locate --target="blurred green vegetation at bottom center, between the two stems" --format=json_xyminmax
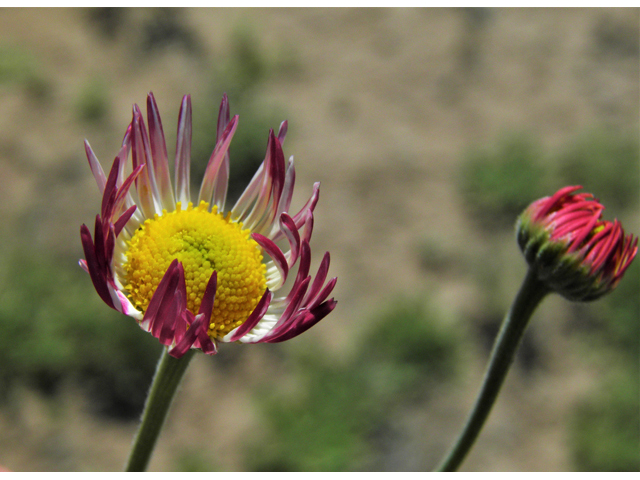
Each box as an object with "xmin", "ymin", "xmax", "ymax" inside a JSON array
[{"xmin": 246, "ymin": 299, "xmax": 460, "ymax": 471}]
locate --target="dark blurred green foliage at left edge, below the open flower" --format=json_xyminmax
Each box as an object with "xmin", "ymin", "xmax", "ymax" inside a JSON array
[{"xmin": 0, "ymin": 249, "xmax": 160, "ymax": 418}]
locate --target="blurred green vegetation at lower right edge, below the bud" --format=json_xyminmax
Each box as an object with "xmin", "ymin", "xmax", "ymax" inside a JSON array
[{"xmin": 571, "ymin": 261, "xmax": 640, "ymax": 471}]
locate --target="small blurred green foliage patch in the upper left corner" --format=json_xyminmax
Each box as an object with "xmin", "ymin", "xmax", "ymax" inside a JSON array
[{"xmin": 0, "ymin": 45, "xmax": 51, "ymax": 100}]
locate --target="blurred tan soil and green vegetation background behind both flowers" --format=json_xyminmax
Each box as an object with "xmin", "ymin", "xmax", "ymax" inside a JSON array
[{"xmin": 0, "ymin": 8, "xmax": 640, "ymax": 471}]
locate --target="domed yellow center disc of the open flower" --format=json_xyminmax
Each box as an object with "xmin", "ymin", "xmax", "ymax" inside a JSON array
[{"xmin": 124, "ymin": 202, "xmax": 266, "ymax": 338}]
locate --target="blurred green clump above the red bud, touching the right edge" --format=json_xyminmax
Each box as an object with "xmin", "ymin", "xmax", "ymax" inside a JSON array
[{"xmin": 554, "ymin": 128, "xmax": 640, "ymax": 211}]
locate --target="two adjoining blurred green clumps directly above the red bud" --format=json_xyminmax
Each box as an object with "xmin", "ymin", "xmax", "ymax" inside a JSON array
[{"xmin": 458, "ymin": 127, "xmax": 640, "ymax": 231}]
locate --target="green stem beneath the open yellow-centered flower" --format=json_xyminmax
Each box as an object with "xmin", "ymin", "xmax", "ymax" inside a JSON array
[{"xmin": 126, "ymin": 349, "xmax": 195, "ymax": 472}]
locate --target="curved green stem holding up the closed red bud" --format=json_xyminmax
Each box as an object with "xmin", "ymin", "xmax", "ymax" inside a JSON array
[{"xmin": 438, "ymin": 268, "xmax": 550, "ymax": 472}]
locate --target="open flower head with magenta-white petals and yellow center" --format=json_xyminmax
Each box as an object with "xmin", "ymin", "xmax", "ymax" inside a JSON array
[{"xmin": 80, "ymin": 93, "xmax": 337, "ymax": 357}]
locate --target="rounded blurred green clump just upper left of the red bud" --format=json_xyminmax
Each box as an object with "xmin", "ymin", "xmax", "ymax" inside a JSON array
[{"xmin": 459, "ymin": 133, "xmax": 544, "ymax": 230}]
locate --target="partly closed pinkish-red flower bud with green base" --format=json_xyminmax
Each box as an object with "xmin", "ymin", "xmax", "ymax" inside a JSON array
[{"xmin": 516, "ymin": 186, "xmax": 638, "ymax": 301}]
